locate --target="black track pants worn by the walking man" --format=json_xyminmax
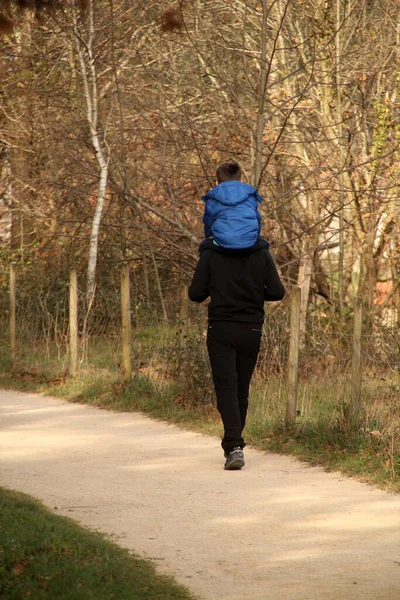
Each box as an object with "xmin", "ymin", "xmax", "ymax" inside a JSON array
[{"xmin": 207, "ymin": 321, "xmax": 262, "ymax": 453}]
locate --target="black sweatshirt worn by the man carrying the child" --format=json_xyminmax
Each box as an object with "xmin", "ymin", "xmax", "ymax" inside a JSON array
[{"xmin": 189, "ymin": 239, "xmax": 285, "ymax": 324}]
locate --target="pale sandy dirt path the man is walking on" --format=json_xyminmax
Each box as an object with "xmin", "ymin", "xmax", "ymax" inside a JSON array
[{"xmin": 0, "ymin": 391, "xmax": 400, "ymax": 600}]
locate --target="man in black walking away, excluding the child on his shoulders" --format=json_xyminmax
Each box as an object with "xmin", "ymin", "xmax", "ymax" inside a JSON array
[{"xmin": 189, "ymin": 238, "xmax": 285, "ymax": 470}]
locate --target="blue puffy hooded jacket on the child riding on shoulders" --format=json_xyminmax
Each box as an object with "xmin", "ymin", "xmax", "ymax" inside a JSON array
[{"xmin": 201, "ymin": 180, "xmax": 262, "ymax": 249}]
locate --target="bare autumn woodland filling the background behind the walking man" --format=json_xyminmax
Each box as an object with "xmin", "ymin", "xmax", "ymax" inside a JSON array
[{"xmin": 0, "ymin": 0, "xmax": 400, "ymax": 482}]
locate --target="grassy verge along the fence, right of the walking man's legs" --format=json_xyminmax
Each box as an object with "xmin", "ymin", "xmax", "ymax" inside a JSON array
[{"xmin": 246, "ymin": 377, "xmax": 400, "ymax": 492}]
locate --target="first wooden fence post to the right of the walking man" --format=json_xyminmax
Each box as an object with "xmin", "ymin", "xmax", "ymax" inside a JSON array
[{"xmin": 286, "ymin": 287, "xmax": 301, "ymax": 427}]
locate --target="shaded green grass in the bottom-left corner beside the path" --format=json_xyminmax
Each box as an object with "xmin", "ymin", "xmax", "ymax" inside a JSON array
[{"xmin": 0, "ymin": 488, "xmax": 194, "ymax": 600}]
